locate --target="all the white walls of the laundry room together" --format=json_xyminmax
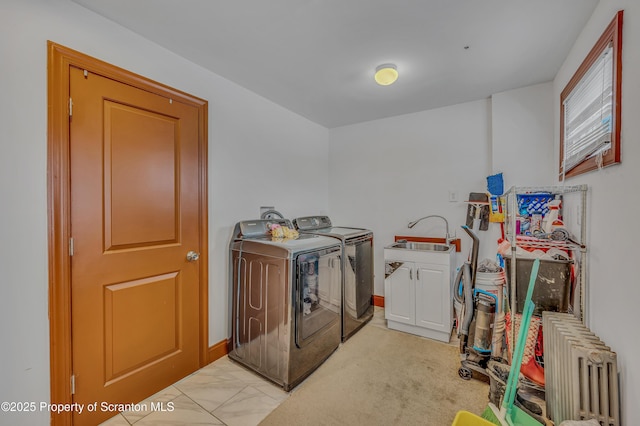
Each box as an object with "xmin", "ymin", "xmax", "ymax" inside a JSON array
[{"xmin": 0, "ymin": 0, "xmax": 640, "ymax": 424}]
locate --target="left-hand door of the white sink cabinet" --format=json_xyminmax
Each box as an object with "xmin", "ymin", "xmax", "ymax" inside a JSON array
[{"xmin": 384, "ymin": 262, "xmax": 416, "ymax": 325}]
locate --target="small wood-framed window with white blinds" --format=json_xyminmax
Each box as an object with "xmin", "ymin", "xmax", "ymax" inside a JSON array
[{"xmin": 560, "ymin": 11, "xmax": 623, "ymax": 180}]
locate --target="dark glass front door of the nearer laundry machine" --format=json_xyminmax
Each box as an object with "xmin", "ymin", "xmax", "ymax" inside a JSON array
[{"xmin": 295, "ymin": 245, "xmax": 342, "ymax": 348}]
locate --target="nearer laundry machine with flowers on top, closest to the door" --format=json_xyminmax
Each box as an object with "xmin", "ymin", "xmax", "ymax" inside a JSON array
[{"xmin": 229, "ymin": 219, "xmax": 342, "ymax": 391}]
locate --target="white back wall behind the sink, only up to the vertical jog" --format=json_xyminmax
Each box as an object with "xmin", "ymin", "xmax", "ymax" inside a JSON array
[{"xmin": 329, "ymin": 100, "xmax": 495, "ymax": 296}]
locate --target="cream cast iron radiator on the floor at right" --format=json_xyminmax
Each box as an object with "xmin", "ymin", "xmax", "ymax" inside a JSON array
[{"xmin": 542, "ymin": 312, "xmax": 620, "ymax": 426}]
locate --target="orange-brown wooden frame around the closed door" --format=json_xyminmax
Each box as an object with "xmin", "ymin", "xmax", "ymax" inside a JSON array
[{"xmin": 47, "ymin": 41, "xmax": 209, "ymax": 425}]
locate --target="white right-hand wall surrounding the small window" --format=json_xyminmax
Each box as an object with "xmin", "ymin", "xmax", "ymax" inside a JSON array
[{"xmin": 553, "ymin": 0, "xmax": 640, "ymax": 425}]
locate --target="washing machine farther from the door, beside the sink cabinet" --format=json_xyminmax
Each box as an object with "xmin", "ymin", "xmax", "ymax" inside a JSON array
[{"xmin": 293, "ymin": 216, "xmax": 374, "ymax": 341}]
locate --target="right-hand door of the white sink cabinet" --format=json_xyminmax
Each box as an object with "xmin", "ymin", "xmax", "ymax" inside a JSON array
[{"xmin": 415, "ymin": 263, "xmax": 452, "ymax": 333}]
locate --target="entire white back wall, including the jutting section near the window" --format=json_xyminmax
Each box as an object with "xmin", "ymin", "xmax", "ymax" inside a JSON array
[{"xmin": 329, "ymin": 83, "xmax": 555, "ymax": 296}]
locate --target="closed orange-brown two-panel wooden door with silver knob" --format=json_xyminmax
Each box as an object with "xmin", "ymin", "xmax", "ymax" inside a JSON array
[{"xmin": 69, "ymin": 67, "xmax": 200, "ymax": 424}]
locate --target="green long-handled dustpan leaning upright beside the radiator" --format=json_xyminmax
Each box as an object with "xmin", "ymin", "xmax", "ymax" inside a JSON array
[{"xmin": 483, "ymin": 259, "xmax": 541, "ymax": 426}]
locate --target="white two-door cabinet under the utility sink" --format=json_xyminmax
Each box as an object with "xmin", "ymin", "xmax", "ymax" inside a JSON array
[{"xmin": 384, "ymin": 247, "xmax": 454, "ymax": 342}]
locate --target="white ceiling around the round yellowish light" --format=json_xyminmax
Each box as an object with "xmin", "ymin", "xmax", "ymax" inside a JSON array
[{"xmin": 73, "ymin": 0, "xmax": 598, "ymax": 128}]
